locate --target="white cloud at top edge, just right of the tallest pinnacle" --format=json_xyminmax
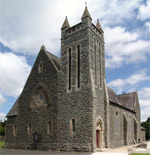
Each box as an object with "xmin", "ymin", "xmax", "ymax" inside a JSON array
[{"xmin": 88, "ymin": 0, "xmax": 142, "ymax": 25}]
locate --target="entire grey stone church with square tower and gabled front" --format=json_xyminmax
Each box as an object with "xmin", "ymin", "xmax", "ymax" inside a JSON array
[{"xmin": 6, "ymin": 7, "xmax": 140, "ymax": 152}]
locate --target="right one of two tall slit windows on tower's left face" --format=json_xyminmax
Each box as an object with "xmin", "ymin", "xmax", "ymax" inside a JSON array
[{"xmin": 77, "ymin": 45, "xmax": 81, "ymax": 88}]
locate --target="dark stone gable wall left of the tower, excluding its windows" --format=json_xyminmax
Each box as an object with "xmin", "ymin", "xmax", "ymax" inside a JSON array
[{"xmin": 6, "ymin": 50, "xmax": 58, "ymax": 149}]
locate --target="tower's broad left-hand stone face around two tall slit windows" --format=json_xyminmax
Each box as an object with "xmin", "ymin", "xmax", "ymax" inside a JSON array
[{"xmin": 58, "ymin": 17, "xmax": 93, "ymax": 151}]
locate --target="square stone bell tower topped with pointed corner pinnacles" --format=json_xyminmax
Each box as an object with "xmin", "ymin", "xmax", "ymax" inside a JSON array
[{"xmin": 58, "ymin": 7, "xmax": 105, "ymax": 151}]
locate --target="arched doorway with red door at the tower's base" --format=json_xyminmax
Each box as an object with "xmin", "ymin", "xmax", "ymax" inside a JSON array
[{"xmin": 96, "ymin": 120, "xmax": 103, "ymax": 148}]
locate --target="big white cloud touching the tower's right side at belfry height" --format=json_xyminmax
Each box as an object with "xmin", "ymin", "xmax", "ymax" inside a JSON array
[{"xmin": 104, "ymin": 27, "xmax": 150, "ymax": 69}]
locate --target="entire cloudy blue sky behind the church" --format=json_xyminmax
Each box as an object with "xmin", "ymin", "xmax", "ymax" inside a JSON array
[{"xmin": 0, "ymin": 0, "xmax": 150, "ymax": 120}]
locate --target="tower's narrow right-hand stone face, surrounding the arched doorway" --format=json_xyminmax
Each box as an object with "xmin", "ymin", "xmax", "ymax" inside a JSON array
[{"xmin": 89, "ymin": 24, "xmax": 105, "ymax": 151}]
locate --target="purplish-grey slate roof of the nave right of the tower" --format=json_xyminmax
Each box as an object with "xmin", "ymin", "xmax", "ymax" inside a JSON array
[{"xmin": 107, "ymin": 88, "xmax": 136, "ymax": 111}]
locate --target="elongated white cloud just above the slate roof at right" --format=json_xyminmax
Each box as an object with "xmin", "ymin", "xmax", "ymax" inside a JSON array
[{"xmin": 107, "ymin": 69, "xmax": 150, "ymax": 93}]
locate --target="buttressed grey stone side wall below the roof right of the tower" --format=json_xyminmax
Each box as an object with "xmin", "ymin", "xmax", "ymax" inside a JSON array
[{"xmin": 110, "ymin": 103, "xmax": 140, "ymax": 148}]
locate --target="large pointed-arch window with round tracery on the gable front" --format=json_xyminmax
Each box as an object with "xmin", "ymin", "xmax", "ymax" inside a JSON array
[{"xmin": 31, "ymin": 85, "xmax": 48, "ymax": 107}]
